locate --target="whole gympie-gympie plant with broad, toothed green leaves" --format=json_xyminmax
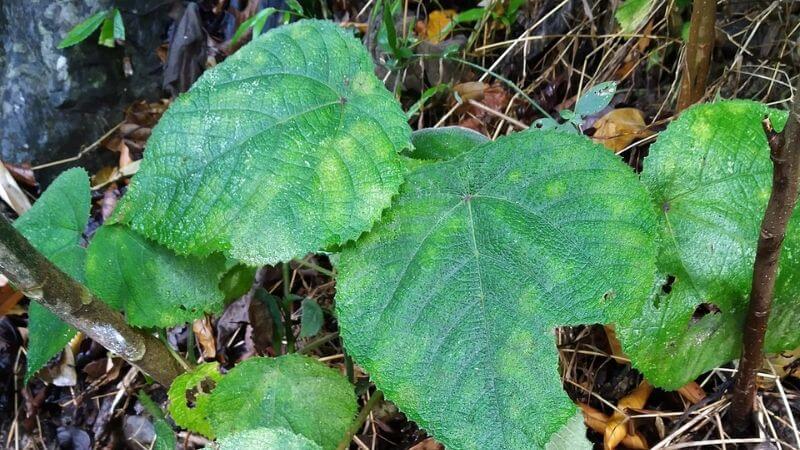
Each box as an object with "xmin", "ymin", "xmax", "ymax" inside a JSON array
[{"xmin": 15, "ymin": 21, "xmax": 800, "ymax": 449}]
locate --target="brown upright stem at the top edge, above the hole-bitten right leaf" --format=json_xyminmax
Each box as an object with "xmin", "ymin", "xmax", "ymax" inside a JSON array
[{"xmin": 676, "ymin": 0, "xmax": 717, "ymax": 112}]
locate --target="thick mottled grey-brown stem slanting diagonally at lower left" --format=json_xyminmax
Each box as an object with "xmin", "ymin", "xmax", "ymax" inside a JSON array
[{"xmin": 0, "ymin": 215, "xmax": 184, "ymax": 386}]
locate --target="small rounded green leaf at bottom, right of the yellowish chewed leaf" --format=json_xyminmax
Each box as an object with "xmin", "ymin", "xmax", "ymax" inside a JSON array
[{"xmin": 208, "ymin": 355, "xmax": 356, "ymax": 449}]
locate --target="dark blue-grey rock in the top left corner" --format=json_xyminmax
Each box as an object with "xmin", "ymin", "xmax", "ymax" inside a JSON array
[{"xmin": 0, "ymin": 0, "xmax": 174, "ymax": 178}]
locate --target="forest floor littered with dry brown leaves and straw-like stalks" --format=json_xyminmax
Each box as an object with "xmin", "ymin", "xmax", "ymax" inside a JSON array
[{"xmin": 0, "ymin": 0, "xmax": 800, "ymax": 450}]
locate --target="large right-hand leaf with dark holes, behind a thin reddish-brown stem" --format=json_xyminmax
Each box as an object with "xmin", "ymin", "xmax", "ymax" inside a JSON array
[{"xmin": 618, "ymin": 101, "xmax": 800, "ymax": 389}]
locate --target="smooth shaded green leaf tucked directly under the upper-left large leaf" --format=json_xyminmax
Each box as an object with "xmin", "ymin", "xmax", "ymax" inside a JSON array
[{"xmin": 86, "ymin": 224, "xmax": 225, "ymax": 327}]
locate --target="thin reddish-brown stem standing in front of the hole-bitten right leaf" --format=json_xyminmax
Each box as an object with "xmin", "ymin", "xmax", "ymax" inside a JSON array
[{"xmin": 731, "ymin": 99, "xmax": 800, "ymax": 431}]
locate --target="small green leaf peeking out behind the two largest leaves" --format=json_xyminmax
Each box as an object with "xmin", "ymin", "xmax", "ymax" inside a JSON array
[{"xmin": 409, "ymin": 127, "xmax": 489, "ymax": 161}]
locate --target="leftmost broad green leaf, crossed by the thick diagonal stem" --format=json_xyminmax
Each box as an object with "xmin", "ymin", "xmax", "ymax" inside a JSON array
[{"xmin": 14, "ymin": 169, "xmax": 91, "ymax": 380}]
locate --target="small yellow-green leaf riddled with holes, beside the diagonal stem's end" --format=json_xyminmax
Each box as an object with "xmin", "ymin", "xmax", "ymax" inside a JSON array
[{"xmin": 167, "ymin": 362, "xmax": 222, "ymax": 438}]
